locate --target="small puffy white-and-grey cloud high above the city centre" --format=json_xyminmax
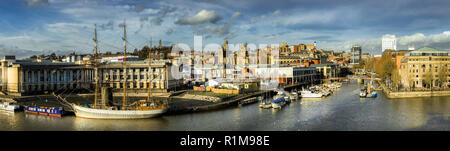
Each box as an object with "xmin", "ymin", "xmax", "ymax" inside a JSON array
[{"xmin": 175, "ymin": 10, "xmax": 222, "ymax": 25}]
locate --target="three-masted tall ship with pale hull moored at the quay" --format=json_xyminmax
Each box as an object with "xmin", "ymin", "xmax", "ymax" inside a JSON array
[{"xmin": 70, "ymin": 20, "xmax": 168, "ymax": 119}]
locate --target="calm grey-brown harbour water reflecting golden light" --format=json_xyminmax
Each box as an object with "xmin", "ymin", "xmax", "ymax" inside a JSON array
[{"xmin": 0, "ymin": 83, "xmax": 450, "ymax": 131}]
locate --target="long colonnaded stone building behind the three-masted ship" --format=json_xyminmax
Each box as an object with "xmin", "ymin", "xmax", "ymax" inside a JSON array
[{"xmin": 0, "ymin": 56, "xmax": 182, "ymax": 95}]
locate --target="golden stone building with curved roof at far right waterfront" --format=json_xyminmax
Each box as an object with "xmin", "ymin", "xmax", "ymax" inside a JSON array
[{"xmin": 399, "ymin": 47, "xmax": 450, "ymax": 88}]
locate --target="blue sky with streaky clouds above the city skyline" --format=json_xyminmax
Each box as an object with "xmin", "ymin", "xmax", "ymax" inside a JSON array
[{"xmin": 0, "ymin": 0, "xmax": 450, "ymax": 58}]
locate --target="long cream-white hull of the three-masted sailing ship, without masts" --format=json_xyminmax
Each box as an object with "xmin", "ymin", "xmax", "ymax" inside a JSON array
[{"xmin": 73, "ymin": 105, "xmax": 167, "ymax": 119}]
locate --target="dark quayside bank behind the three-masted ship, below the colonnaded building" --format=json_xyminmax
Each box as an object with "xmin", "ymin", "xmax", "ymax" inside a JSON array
[{"xmin": 0, "ymin": 91, "xmax": 270, "ymax": 114}]
